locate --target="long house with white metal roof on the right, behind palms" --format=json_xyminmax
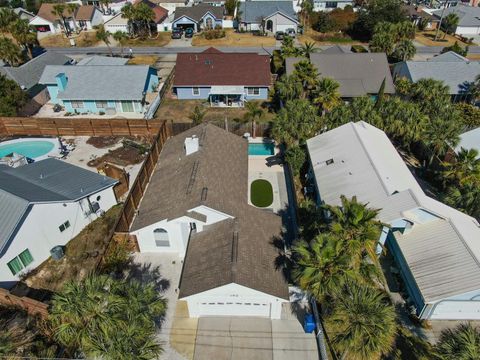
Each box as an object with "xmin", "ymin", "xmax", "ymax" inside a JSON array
[{"xmin": 307, "ymin": 121, "xmax": 480, "ymax": 320}]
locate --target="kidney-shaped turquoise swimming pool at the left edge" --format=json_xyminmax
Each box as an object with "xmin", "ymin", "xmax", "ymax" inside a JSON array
[{"xmin": 0, "ymin": 138, "xmax": 58, "ymax": 160}]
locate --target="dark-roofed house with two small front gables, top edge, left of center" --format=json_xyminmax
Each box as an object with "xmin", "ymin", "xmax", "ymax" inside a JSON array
[{"xmin": 172, "ymin": 4, "xmax": 225, "ymax": 32}]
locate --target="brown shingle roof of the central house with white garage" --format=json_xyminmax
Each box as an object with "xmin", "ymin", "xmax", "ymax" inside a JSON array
[{"xmin": 131, "ymin": 124, "xmax": 288, "ymax": 299}]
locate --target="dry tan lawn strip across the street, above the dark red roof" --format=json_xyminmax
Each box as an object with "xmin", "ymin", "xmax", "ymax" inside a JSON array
[{"xmin": 192, "ymin": 29, "xmax": 275, "ymax": 46}]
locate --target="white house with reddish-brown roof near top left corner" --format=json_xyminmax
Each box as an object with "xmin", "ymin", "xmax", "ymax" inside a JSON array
[{"xmin": 30, "ymin": 3, "xmax": 103, "ymax": 34}]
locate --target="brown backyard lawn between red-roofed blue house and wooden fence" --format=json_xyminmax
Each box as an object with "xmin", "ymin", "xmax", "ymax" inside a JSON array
[{"xmin": 156, "ymin": 99, "xmax": 274, "ymax": 123}]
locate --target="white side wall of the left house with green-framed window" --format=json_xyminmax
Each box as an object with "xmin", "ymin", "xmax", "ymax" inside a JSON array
[{"xmin": 0, "ymin": 187, "xmax": 117, "ymax": 287}]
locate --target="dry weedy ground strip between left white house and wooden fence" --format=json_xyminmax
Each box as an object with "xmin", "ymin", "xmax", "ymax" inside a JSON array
[{"xmin": 25, "ymin": 205, "xmax": 121, "ymax": 292}]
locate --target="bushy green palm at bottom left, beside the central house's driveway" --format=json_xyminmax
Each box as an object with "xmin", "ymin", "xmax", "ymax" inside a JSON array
[{"xmin": 49, "ymin": 274, "xmax": 166, "ymax": 359}]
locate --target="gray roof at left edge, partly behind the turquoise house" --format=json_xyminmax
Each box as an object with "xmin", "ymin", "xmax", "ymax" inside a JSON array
[{"xmin": 0, "ymin": 51, "xmax": 72, "ymax": 94}]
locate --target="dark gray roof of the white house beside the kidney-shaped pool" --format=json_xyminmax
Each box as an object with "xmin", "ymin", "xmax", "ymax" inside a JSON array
[{"xmin": 0, "ymin": 159, "xmax": 117, "ymax": 253}]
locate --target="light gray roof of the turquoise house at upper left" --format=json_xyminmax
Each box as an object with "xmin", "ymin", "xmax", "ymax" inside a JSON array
[{"xmin": 40, "ymin": 65, "xmax": 156, "ymax": 100}]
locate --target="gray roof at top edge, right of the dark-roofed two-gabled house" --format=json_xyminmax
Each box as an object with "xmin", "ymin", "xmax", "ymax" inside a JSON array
[{"xmin": 239, "ymin": 1, "xmax": 298, "ymax": 23}]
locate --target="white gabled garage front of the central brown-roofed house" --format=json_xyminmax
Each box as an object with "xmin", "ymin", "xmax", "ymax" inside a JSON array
[{"xmin": 182, "ymin": 283, "xmax": 287, "ymax": 319}]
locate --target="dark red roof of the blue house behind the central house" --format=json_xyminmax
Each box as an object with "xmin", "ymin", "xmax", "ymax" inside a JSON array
[{"xmin": 173, "ymin": 48, "xmax": 271, "ymax": 86}]
